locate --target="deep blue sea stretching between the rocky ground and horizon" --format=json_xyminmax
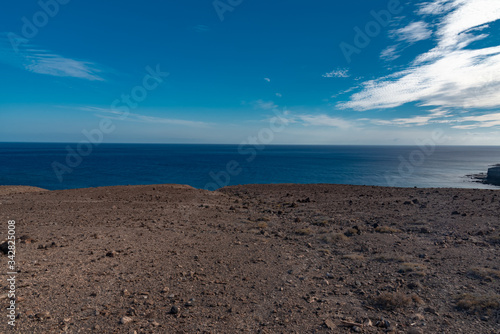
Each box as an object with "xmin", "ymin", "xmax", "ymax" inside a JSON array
[{"xmin": 0, "ymin": 143, "xmax": 500, "ymax": 190}]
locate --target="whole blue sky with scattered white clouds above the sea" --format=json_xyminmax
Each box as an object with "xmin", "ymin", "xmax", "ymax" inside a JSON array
[{"xmin": 0, "ymin": 0, "xmax": 500, "ymax": 145}]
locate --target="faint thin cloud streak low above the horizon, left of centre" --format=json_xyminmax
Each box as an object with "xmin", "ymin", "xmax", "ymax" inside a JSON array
[{"xmin": 79, "ymin": 107, "xmax": 210, "ymax": 128}]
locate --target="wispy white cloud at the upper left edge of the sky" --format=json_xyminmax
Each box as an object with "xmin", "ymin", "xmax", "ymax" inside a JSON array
[{"xmin": 0, "ymin": 35, "xmax": 104, "ymax": 81}]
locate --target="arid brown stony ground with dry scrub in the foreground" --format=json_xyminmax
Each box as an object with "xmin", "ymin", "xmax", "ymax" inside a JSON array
[{"xmin": 0, "ymin": 185, "xmax": 500, "ymax": 334}]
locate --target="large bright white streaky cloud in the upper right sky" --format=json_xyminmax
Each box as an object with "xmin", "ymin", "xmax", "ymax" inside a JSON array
[{"xmin": 338, "ymin": 0, "xmax": 500, "ymax": 121}]
